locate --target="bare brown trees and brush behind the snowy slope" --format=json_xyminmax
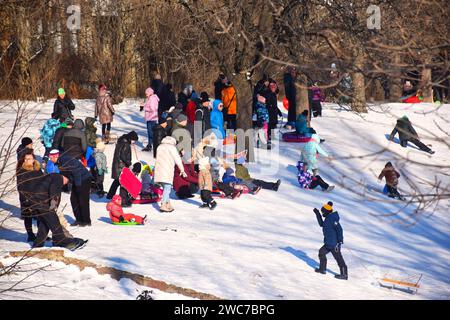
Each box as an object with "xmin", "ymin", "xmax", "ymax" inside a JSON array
[{"xmin": 0, "ymin": 0, "xmax": 450, "ymax": 129}]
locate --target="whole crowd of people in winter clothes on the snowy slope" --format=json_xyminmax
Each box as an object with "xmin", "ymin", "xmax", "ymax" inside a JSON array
[{"xmin": 17, "ymin": 68, "xmax": 434, "ymax": 279}]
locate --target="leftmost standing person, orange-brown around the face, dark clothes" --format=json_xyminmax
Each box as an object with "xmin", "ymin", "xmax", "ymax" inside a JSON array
[{"xmin": 16, "ymin": 149, "xmax": 44, "ymax": 242}]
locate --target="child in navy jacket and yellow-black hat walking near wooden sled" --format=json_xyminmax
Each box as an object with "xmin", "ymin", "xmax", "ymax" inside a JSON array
[{"xmin": 313, "ymin": 201, "xmax": 348, "ymax": 280}]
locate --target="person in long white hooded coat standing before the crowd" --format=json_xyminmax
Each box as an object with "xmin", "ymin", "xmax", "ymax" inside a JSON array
[{"xmin": 155, "ymin": 136, "xmax": 187, "ymax": 212}]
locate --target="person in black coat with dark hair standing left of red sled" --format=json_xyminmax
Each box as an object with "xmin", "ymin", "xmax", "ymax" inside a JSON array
[{"xmin": 106, "ymin": 131, "xmax": 138, "ymax": 207}]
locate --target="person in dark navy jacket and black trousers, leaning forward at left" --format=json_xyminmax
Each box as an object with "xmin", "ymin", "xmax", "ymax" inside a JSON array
[{"xmin": 56, "ymin": 154, "xmax": 92, "ymax": 227}]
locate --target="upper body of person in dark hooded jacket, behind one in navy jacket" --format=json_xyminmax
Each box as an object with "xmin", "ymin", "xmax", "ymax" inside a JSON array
[{"xmin": 61, "ymin": 119, "xmax": 87, "ymax": 160}]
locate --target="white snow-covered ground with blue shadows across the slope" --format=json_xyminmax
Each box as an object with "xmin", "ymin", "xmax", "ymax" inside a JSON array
[{"xmin": 0, "ymin": 100, "xmax": 450, "ymax": 299}]
